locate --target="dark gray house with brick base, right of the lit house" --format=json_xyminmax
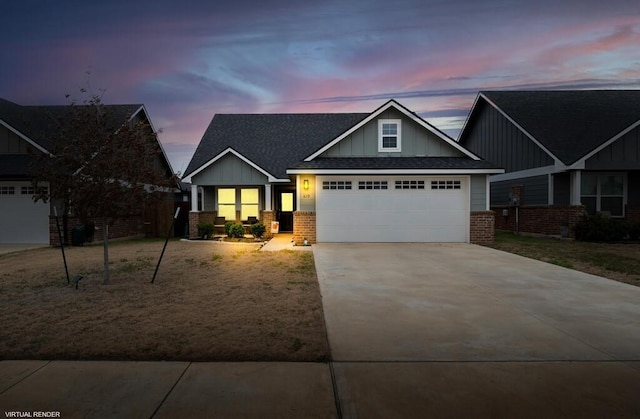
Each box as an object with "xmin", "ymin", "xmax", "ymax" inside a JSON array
[{"xmin": 459, "ymin": 90, "xmax": 640, "ymax": 235}]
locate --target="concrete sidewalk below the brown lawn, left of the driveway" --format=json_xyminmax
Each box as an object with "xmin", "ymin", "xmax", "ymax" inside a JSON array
[{"xmin": 0, "ymin": 361, "xmax": 337, "ymax": 418}]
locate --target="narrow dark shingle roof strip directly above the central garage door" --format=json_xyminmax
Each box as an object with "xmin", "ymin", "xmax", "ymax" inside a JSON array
[{"xmin": 291, "ymin": 157, "xmax": 499, "ymax": 170}]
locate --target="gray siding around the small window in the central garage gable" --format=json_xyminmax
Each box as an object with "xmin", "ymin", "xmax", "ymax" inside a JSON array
[{"xmin": 321, "ymin": 109, "xmax": 463, "ymax": 157}]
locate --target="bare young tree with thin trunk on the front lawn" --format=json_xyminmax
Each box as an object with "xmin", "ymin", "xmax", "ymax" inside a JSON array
[{"xmin": 32, "ymin": 89, "xmax": 176, "ymax": 284}]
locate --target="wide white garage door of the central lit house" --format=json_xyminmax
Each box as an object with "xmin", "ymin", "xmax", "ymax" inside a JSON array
[{"xmin": 316, "ymin": 176, "xmax": 469, "ymax": 242}]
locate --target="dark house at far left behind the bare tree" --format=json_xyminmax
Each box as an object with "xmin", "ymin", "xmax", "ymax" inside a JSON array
[{"xmin": 0, "ymin": 99, "xmax": 179, "ymax": 244}]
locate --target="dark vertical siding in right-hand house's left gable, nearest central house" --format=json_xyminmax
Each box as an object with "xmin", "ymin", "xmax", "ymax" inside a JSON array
[{"xmin": 460, "ymin": 104, "xmax": 554, "ymax": 173}]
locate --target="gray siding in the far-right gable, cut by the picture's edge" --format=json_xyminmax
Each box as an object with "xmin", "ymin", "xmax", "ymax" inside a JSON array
[{"xmin": 585, "ymin": 124, "xmax": 640, "ymax": 170}]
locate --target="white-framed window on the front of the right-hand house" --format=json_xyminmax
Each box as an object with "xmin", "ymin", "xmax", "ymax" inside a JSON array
[{"xmin": 580, "ymin": 173, "xmax": 625, "ymax": 217}]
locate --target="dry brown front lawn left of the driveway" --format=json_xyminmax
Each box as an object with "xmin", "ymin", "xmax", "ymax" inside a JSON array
[{"xmin": 0, "ymin": 240, "xmax": 330, "ymax": 361}]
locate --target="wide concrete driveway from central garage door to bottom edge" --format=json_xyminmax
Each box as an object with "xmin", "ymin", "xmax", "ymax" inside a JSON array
[{"xmin": 314, "ymin": 244, "xmax": 640, "ymax": 417}]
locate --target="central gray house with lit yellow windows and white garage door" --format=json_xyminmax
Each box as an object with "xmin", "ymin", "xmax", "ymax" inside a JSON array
[{"xmin": 185, "ymin": 100, "xmax": 503, "ymax": 244}]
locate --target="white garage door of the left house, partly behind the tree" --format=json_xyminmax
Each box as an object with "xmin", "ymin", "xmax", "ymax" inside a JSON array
[{"xmin": 0, "ymin": 182, "xmax": 49, "ymax": 244}]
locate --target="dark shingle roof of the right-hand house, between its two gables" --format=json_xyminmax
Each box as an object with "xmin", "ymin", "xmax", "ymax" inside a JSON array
[{"xmin": 480, "ymin": 90, "xmax": 640, "ymax": 164}]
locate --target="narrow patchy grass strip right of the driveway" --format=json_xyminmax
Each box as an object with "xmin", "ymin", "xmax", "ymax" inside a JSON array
[{"xmin": 489, "ymin": 231, "xmax": 640, "ymax": 286}]
